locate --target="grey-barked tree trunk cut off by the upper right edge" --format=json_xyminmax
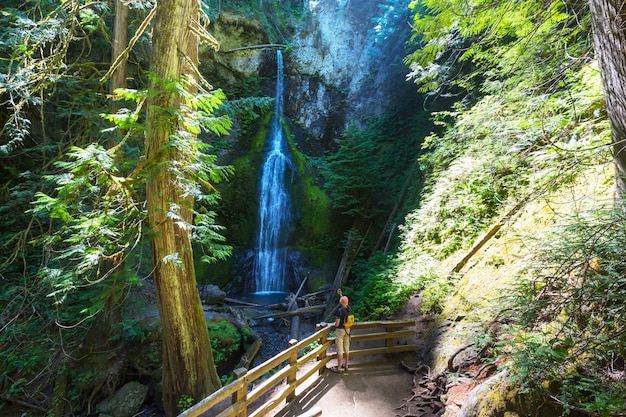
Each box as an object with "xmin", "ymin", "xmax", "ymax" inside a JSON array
[{"xmin": 589, "ymin": 0, "xmax": 626, "ymax": 200}]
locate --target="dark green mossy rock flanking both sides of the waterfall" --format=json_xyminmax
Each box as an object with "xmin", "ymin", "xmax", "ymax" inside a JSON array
[{"xmin": 197, "ymin": 112, "xmax": 343, "ymax": 290}]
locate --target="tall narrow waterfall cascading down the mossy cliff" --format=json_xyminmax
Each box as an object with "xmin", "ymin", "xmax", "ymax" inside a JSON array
[{"xmin": 254, "ymin": 50, "xmax": 293, "ymax": 293}]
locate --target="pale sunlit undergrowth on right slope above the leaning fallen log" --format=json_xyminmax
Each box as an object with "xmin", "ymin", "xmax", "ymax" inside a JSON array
[{"xmin": 398, "ymin": 59, "xmax": 610, "ymax": 259}]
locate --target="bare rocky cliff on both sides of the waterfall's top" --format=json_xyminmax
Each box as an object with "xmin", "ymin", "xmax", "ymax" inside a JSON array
[{"xmin": 206, "ymin": 0, "xmax": 418, "ymax": 146}]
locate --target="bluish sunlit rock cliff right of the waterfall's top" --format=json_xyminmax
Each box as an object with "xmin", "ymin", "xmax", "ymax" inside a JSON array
[{"xmin": 285, "ymin": 0, "xmax": 415, "ymax": 143}]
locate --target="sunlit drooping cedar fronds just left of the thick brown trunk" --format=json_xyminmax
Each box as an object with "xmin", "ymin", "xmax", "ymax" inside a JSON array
[{"xmin": 32, "ymin": 140, "xmax": 145, "ymax": 302}]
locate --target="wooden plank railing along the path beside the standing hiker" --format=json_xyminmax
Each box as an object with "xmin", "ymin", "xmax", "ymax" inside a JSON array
[{"xmin": 179, "ymin": 320, "xmax": 415, "ymax": 417}]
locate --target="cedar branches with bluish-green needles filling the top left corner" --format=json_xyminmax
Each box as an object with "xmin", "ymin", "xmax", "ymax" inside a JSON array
[{"xmin": 0, "ymin": 1, "xmax": 112, "ymax": 150}]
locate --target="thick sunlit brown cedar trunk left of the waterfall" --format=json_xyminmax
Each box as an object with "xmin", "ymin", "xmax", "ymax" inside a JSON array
[{"xmin": 146, "ymin": 0, "xmax": 221, "ymax": 416}]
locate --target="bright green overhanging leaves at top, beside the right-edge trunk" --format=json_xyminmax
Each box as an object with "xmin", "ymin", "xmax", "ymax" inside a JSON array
[{"xmin": 406, "ymin": 0, "xmax": 590, "ymax": 93}]
